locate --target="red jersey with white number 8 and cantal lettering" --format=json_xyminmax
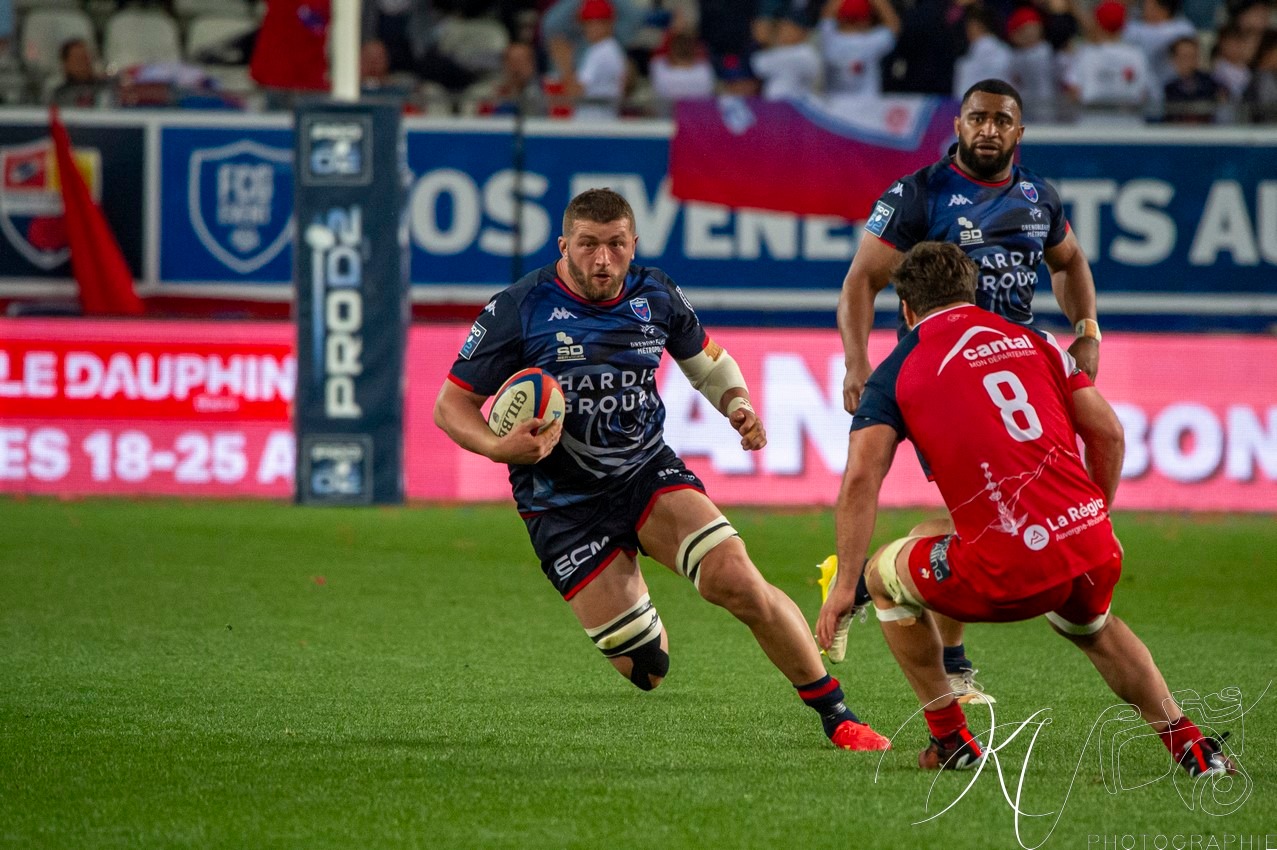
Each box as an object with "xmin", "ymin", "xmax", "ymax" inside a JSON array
[{"xmin": 852, "ymin": 305, "xmax": 1117, "ymax": 601}]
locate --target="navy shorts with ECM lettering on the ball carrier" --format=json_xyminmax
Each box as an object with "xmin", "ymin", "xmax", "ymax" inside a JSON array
[{"xmin": 524, "ymin": 445, "xmax": 705, "ymax": 599}]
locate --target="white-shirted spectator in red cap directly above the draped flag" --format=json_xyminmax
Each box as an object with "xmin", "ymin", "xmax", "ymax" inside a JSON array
[{"xmin": 819, "ymin": 0, "xmax": 900, "ymax": 94}]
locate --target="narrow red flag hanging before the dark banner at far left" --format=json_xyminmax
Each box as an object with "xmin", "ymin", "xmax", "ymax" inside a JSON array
[{"xmin": 49, "ymin": 106, "xmax": 146, "ymax": 315}]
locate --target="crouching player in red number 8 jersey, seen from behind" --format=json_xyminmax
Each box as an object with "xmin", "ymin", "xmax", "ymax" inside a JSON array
[{"xmin": 817, "ymin": 242, "xmax": 1234, "ymax": 776}]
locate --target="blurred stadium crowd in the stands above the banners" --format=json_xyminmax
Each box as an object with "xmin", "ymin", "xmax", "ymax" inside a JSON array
[{"xmin": 0, "ymin": 0, "xmax": 1277, "ymax": 124}]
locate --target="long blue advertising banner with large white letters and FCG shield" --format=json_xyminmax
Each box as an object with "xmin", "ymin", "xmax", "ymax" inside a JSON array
[{"xmin": 146, "ymin": 120, "xmax": 1277, "ymax": 324}]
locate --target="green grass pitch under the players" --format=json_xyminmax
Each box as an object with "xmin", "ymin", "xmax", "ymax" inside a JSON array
[{"xmin": 0, "ymin": 499, "xmax": 1277, "ymax": 850}]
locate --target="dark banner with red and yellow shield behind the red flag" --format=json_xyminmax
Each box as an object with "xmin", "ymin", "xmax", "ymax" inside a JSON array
[{"xmin": 0, "ymin": 121, "xmax": 146, "ymax": 280}]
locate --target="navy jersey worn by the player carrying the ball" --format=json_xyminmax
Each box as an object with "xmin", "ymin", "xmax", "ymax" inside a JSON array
[{"xmin": 448, "ymin": 264, "xmax": 709, "ymax": 513}]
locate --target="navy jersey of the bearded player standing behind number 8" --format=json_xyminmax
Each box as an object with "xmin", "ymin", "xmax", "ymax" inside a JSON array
[{"xmin": 865, "ymin": 145, "xmax": 1069, "ymax": 324}]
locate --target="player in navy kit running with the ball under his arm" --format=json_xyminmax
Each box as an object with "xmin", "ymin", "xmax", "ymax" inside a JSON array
[{"xmin": 434, "ymin": 189, "xmax": 889, "ymax": 749}]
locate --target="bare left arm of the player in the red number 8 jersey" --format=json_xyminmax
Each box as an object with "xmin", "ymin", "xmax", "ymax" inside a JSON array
[{"xmin": 816, "ymin": 425, "xmax": 899, "ymax": 650}]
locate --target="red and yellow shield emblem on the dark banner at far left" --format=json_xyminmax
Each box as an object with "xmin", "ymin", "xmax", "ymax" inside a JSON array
[{"xmin": 0, "ymin": 138, "xmax": 102, "ymax": 272}]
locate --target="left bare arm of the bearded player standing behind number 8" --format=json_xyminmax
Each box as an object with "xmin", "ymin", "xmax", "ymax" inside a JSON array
[{"xmin": 838, "ymin": 234, "xmax": 904, "ymax": 414}]
